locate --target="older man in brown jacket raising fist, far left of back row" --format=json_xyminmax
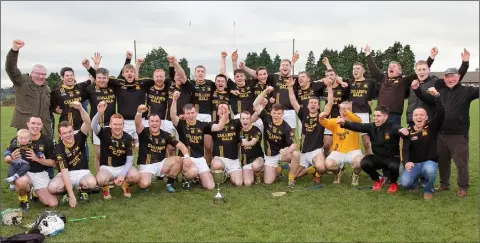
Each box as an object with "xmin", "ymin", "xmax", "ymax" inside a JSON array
[{"xmin": 5, "ymin": 40, "xmax": 53, "ymax": 139}]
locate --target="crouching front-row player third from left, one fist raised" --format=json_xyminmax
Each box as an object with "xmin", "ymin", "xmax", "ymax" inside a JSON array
[{"xmin": 92, "ymin": 102, "xmax": 139, "ymax": 199}]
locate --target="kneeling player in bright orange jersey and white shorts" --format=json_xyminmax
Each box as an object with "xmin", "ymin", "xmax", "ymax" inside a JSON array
[{"xmin": 320, "ymin": 101, "xmax": 363, "ymax": 186}]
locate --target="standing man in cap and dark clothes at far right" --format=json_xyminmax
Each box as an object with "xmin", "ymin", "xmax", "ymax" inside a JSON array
[{"xmin": 417, "ymin": 68, "xmax": 479, "ymax": 198}]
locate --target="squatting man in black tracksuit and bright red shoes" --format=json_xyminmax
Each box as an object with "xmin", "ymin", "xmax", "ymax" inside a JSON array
[{"xmin": 341, "ymin": 105, "xmax": 409, "ymax": 194}]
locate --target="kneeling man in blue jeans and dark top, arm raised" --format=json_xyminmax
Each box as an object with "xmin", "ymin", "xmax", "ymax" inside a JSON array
[{"xmin": 400, "ymin": 83, "xmax": 445, "ymax": 200}]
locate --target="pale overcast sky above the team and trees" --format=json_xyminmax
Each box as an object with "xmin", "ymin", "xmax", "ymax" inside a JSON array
[{"xmin": 1, "ymin": 1, "xmax": 479, "ymax": 87}]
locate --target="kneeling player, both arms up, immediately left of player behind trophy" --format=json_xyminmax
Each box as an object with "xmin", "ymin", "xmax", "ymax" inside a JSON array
[{"xmin": 170, "ymin": 91, "xmax": 227, "ymax": 190}]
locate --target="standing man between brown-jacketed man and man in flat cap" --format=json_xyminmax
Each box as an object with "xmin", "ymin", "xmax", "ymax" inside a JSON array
[{"xmin": 407, "ymin": 47, "xmax": 470, "ymax": 126}]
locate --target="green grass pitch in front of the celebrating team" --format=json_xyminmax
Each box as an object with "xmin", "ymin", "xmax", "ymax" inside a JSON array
[{"xmin": 0, "ymin": 101, "xmax": 479, "ymax": 242}]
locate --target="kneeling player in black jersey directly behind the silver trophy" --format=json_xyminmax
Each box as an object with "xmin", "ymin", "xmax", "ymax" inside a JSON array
[{"xmin": 211, "ymin": 103, "xmax": 243, "ymax": 186}]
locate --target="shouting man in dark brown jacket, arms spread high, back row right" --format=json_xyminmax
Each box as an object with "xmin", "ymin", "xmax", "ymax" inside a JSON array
[{"xmin": 363, "ymin": 45, "xmax": 434, "ymax": 125}]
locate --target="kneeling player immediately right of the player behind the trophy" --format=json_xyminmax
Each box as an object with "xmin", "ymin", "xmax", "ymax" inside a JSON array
[{"xmin": 240, "ymin": 111, "xmax": 265, "ymax": 186}]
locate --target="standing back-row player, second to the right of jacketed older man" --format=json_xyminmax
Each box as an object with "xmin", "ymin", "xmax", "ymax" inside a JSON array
[{"xmin": 85, "ymin": 68, "xmax": 117, "ymax": 172}]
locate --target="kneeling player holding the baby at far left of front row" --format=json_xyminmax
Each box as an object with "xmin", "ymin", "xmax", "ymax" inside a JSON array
[{"xmin": 4, "ymin": 116, "xmax": 58, "ymax": 211}]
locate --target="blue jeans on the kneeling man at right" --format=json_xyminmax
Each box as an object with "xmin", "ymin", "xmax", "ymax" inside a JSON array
[{"xmin": 400, "ymin": 160, "xmax": 438, "ymax": 193}]
